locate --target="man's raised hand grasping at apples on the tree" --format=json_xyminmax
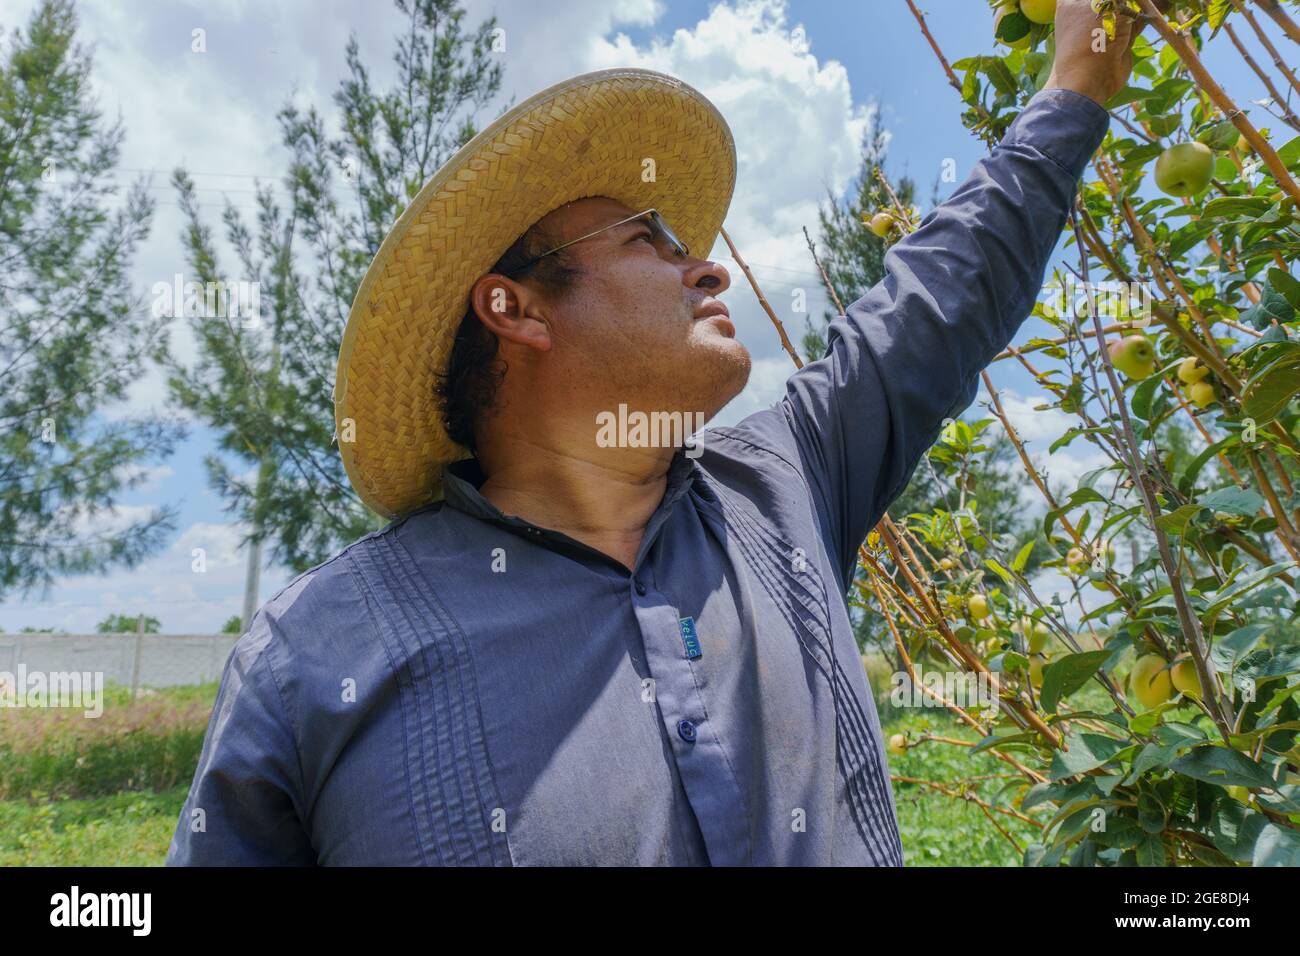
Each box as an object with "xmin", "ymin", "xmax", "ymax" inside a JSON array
[{"xmin": 1044, "ymin": 0, "xmax": 1167, "ymax": 104}]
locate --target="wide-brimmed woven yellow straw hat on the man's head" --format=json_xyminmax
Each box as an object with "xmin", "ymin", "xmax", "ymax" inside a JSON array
[{"xmin": 334, "ymin": 69, "xmax": 736, "ymax": 518}]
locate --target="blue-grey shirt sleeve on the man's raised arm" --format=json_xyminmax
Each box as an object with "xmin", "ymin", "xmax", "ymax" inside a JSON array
[{"xmin": 724, "ymin": 90, "xmax": 1109, "ymax": 589}]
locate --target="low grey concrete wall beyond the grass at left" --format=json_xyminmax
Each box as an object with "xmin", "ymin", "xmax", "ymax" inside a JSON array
[{"xmin": 0, "ymin": 633, "xmax": 239, "ymax": 687}]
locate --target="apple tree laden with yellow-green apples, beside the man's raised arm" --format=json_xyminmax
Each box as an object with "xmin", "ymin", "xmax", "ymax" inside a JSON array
[{"xmin": 832, "ymin": 0, "xmax": 1300, "ymax": 866}]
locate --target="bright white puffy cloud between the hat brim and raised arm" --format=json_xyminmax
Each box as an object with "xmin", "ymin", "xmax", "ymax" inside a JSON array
[{"xmin": 584, "ymin": 0, "xmax": 870, "ymax": 371}]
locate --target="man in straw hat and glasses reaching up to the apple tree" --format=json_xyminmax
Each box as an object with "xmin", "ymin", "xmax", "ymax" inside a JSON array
[{"xmin": 168, "ymin": 0, "xmax": 1130, "ymax": 865}]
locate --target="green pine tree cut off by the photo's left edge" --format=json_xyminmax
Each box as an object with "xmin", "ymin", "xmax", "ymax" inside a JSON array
[{"xmin": 0, "ymin": 0, "xmax": 183, "ymax": 594}]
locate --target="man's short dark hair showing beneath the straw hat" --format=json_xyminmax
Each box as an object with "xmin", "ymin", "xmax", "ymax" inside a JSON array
[{"xmin": 433, "ymin": 222, "xmax": 581, "ymax": 451}]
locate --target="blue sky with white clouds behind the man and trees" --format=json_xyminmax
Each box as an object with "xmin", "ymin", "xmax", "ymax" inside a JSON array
[{"xmin": 0, "ymin": 0, "xmax": 1288, "ymax": 633}]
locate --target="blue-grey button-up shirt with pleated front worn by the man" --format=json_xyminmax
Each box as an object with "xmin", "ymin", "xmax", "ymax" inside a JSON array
[{"xmin": 168, "ymin": 90, "xmax": 1108, "ymax": 866}]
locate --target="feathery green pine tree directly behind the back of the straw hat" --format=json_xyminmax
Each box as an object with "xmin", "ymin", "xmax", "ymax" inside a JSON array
[{"xmin": 169, "ymin": 0, "xmax": 502, "ymax": 571}]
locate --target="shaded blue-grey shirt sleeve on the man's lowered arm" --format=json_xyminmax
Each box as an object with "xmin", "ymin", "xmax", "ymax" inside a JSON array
[{"xmin": 166, "ymin": 609, "xmax": 316, "ymax": 866}]
